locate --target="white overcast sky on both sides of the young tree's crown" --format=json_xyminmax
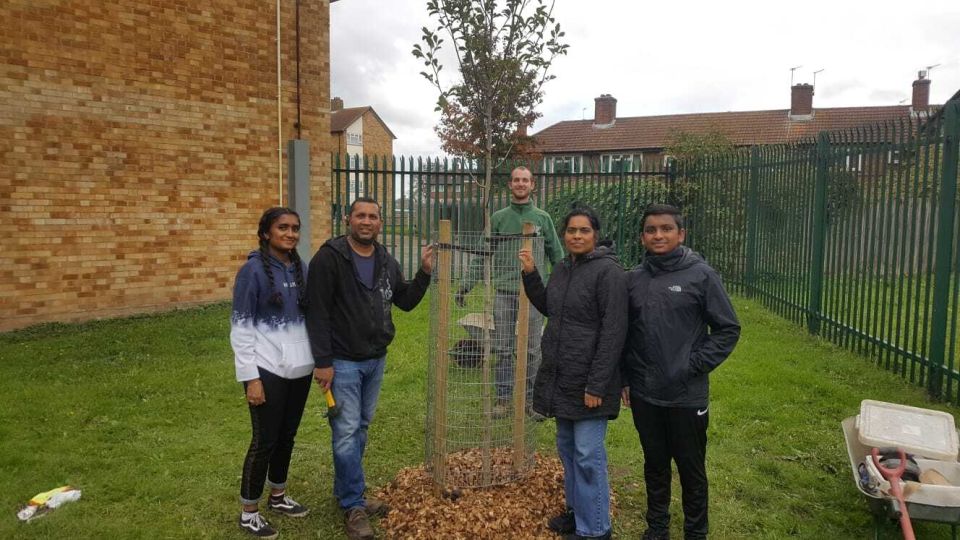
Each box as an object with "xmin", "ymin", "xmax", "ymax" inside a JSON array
[{"xmin": 330, "ymin": 0, "xmax": 960, "ymax": 156}]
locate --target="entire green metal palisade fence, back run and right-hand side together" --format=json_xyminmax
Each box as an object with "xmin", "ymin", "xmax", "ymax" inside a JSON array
[{"xmin": 331, "ymin": 102, "xmax": 960, "ymax": 403}]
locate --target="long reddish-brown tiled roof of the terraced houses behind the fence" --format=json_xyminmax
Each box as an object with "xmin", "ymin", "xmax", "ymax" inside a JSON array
[{"xmin": 533, "ymin": 105, "xmax": 933, "ymax": 153}]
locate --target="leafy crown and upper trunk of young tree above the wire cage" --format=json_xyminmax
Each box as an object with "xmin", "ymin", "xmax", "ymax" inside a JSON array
[{"xmin": 413, "ymin": 0, "xmax": 569, "ymax": 230}]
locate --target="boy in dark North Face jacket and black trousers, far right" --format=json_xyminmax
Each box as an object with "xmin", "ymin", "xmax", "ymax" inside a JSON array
[{"xmin": 623, "ymin": 205, "xmax": 740, "ymax": 540}]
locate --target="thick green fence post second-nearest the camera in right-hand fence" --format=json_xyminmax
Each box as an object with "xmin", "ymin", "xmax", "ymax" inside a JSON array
[{"xmin": 807, "ymin": 132, "xmax": 831, "ymax": 334}]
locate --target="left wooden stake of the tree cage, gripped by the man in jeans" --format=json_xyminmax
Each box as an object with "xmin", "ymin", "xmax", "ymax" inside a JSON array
[{"xmin": 433, "ymin": 219, "xmax": 453, "ymax": 488}]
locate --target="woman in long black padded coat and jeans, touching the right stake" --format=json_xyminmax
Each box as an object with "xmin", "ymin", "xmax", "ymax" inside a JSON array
[{"xmin": 520, "ymin": 209, "xmax": 627, "ymax": 539}]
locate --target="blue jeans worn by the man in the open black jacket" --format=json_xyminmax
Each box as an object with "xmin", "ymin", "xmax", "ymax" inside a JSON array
[{"xmin": 330, "ymin": 358, "xmax": 386, "ymax": 510}]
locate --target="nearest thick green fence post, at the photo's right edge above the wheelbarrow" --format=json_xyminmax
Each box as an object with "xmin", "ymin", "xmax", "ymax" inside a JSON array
[{"xmin": 927, "ymin": 102, "xmax": 960, "ymax": 398}]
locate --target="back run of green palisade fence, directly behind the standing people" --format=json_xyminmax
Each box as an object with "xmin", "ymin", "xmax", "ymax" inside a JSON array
[{"xmin": 330, "ymin": 155, "xmax": 680, "ymax": 275}]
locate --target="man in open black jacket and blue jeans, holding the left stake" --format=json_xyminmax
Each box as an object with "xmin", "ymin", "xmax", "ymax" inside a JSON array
[{"xmin": 306, "ymin": 197, "xmax": 433, "ymax": 539}]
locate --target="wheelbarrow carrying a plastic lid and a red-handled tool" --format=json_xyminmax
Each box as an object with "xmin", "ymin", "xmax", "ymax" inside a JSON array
[{"xmin": 841, "ymin": 416, "xmax": 960, "ymax": 540}]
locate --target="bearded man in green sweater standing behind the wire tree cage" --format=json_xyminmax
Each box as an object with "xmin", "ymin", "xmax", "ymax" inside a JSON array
[{"xmin": 456, "ymin": 166, "xmax": 563, "ymax": 418}]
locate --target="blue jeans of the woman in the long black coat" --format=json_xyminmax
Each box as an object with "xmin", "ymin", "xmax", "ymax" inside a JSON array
[{"xmin": 557, "ymin": 418, "xmax": 610, "ymax": 536}]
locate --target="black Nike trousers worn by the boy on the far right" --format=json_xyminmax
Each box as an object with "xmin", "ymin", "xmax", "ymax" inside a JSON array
[{"xmin": 630, "ymin": 394, "xmax": 710, "ymax": 540}]
